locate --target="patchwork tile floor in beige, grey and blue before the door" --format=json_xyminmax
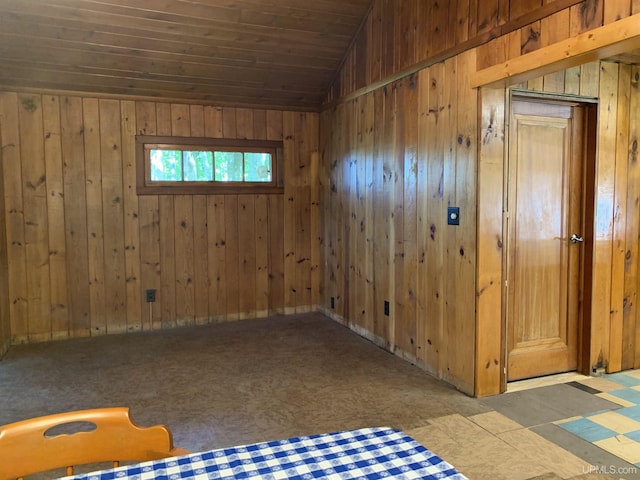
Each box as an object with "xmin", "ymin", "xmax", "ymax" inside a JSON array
[{"xmin": 468, "ymin": 371, "xmax": 640, "ymax": 480}]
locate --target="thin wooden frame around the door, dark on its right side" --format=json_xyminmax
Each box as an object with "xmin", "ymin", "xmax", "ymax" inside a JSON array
[{"xmin": 500, "ymin": 88, "xmax": 598, "ymax": 393}]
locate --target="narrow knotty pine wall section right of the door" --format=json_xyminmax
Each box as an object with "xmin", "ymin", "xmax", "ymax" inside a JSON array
[{"xmin": 591, "ymin": 62, "xmax": 640, "ymax": 372}]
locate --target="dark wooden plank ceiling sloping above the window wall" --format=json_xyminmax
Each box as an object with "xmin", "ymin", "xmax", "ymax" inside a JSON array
[{"xmin": 0, "ymin": 0, "xmax": 371, "ymax": 110}]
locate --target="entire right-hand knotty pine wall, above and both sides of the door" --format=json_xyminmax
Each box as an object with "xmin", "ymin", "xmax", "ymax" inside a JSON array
[{"xmin": 320, "ymin": 0, "xmax": 640, "ymax": 395}]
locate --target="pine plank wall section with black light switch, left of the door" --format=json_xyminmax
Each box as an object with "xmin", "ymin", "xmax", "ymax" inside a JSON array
[{"xmin": 320, "ymin": 52, "xmax": 477, "ymax": 393}]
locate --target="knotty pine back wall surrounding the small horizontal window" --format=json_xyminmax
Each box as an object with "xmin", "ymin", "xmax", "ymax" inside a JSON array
[{"xmin": 0, "ymin": 92, "xmax": 319, "ymax": 345}]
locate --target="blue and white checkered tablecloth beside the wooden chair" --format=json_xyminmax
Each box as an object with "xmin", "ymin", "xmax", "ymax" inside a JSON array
[{"xmin": 62, "ymin": 428, "xmax": 466, "ymax": 480}]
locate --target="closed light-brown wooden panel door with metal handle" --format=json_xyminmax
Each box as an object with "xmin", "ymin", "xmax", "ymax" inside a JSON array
[{"xmin": 506, "ymin": 100, "xmax": 584, "ymax": 380}]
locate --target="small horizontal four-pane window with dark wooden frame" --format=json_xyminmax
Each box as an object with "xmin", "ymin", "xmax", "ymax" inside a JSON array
[{"xmin": 136, "ymin": 135, "xmax": 283, "ymax": 195}]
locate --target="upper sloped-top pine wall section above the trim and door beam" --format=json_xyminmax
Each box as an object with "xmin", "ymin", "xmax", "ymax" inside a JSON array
[{"xmin": 327, "ymin": 0, "xmax": 640, "ymax": 102}]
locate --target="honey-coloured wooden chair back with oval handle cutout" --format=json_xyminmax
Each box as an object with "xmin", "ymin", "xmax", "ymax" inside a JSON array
[{"xmin": 0, "ymin": 407, "xmax": 189, "ymax": 480}]
